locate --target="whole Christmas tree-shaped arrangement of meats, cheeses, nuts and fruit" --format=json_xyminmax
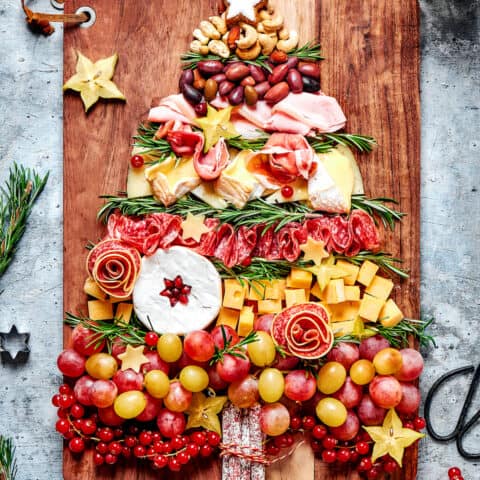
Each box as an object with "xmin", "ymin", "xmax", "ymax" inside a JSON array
[{"xmin": 52, "ymin": 0, "xmax": 430, "ymax": 480}]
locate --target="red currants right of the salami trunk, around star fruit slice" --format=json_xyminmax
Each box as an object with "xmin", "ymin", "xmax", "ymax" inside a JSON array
[{"xmin": 265, "ymin": 415, "xmax": 428, "ymax": 480}]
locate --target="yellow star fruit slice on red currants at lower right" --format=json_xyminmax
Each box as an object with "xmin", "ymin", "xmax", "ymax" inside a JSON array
[{"xmin": 363, "ymin": 408, "xmax": 425, "ymax": 467}]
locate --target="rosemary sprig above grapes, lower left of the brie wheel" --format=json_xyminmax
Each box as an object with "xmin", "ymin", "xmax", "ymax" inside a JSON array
[{"xmin": 64, "ymin": 312, "xmax": 147, "ymax": 352}]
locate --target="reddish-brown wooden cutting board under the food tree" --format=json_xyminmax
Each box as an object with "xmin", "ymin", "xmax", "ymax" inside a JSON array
[{"xmin": 64, "ymin": 0, "xmax": 420, "ymax": 480}]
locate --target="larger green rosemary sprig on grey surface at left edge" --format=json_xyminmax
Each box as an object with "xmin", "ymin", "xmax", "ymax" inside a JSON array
[{"xmin": 0, "ymin": 163, "xmax": 48, "ymax": 276}]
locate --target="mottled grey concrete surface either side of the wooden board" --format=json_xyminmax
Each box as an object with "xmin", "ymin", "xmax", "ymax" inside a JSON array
[{"xmin": 0, "ymin": 0, "xmax": 480, "ymax": 480}]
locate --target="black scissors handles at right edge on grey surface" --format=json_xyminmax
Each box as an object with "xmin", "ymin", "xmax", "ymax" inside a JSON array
[{"xmin": 425, "ymin": 365, "xmax": 480, "ymax": 460}]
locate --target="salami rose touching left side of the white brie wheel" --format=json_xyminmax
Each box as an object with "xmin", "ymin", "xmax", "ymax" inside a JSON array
[{"xmin": 87, "ymin": 240, "xmax": 141, "ymax": 298}]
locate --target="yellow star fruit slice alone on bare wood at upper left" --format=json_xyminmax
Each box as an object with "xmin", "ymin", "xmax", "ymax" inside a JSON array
[{"xmin": 63, "ymin": 52, "xmax": 125, "ymax": 112}]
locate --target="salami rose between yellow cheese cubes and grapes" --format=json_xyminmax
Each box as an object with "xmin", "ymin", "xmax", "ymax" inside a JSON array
[{"xmin": 271, "ymin": 303, "xmax": 333, "ymax": 359}]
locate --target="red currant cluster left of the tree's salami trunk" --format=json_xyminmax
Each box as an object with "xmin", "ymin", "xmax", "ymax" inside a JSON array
[{"xmin": 52, "ymin": 384, "xmax": 220, "ymax": 472}]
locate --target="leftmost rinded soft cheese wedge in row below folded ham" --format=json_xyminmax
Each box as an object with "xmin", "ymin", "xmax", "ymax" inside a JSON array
[{"xmin": 145, "ymin": 157, "xmax": 201, "ymax": 206}]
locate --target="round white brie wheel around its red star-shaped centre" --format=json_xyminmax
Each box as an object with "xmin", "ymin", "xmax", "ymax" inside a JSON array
[{"xmin": 133, "ymin": 247, "xmax": 222, "ymax": 335}]
